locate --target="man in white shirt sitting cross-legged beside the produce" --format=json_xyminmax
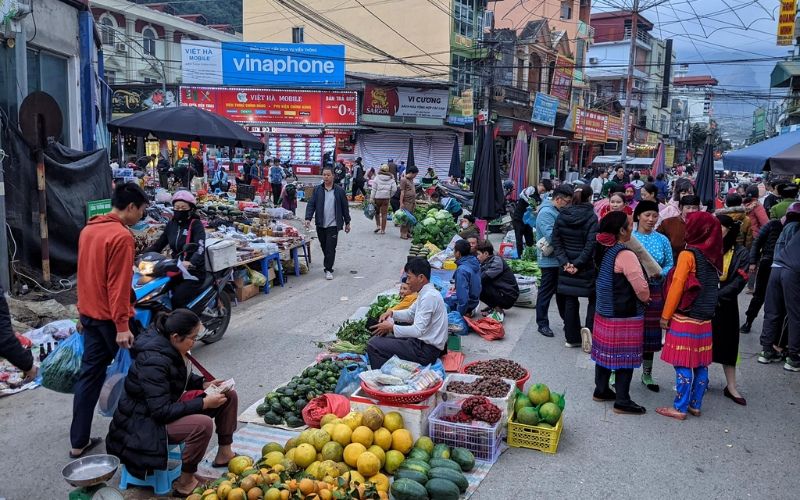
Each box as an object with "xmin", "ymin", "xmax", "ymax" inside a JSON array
[{"xmin": 367, "ymin": 258, "xmax": 447, "ymax": 370}]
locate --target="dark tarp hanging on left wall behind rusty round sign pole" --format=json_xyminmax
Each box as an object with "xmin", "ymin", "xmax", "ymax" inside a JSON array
[{"xmin": 3, "ymin": 127, "xmax": 111, "ymax": 277}]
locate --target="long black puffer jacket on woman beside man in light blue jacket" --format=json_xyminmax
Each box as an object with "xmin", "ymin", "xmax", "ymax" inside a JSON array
[{"xmin": 553, "ymin": 203, "xmax": 597, "ymax": 297}]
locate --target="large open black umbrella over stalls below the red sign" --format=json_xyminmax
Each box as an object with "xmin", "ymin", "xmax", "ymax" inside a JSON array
[{"xmin": 108, "ymin": 106, "xmax": 264, "ymax": 149}]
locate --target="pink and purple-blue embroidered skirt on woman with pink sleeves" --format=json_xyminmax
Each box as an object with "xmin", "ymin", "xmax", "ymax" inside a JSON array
[{"xmin": 592, "ymin": 313, "xmax": 644, "ymax": 370}]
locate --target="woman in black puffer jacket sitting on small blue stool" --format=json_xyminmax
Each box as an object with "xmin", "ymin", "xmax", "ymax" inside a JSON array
[{"xmin": 106, "ymin": 309, "xmax": 238, "ymax": 496}]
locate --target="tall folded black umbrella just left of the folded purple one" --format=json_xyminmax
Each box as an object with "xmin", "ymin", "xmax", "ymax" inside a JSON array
[{"xmin": 472, "ymin": 126, "xmax": 506, "ymax": 221}]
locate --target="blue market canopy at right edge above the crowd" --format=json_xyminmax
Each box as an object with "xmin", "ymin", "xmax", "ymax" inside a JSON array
[{"xmin": 722, "ymin": 132, "xmax": 800, "ymax": 175}]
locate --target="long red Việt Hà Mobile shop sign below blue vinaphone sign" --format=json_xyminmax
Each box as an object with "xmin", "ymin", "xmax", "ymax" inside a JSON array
[{"xmin": 181, "ymin": 87, "xmax": 358, "ymax": 126}]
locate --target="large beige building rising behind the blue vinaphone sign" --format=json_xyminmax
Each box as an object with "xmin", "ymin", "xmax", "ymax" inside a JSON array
[{"xmin": 243, "ymin": 0, "xmax": 499, "ymax": 125}]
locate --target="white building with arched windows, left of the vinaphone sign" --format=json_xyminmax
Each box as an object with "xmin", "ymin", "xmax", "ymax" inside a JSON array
[{"xmin": 91, "ymin": 0, "xmax": 242, "ymax": 86}]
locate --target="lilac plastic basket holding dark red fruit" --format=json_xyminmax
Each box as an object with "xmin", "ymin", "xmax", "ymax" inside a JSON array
[{"xmin": 428, "ymin": 403, "xmax": 505, "ymax": 463}]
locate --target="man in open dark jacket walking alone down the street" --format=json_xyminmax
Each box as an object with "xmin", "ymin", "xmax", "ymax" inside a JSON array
[{"xmin": 306, "ymin": 167, "xmax": 350, "ymax": 280}]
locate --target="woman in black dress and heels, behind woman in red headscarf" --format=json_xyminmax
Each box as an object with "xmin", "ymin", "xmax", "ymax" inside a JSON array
[{"xmin": 711, "ymin": 215, "xmax": 750, "ymax": 406}]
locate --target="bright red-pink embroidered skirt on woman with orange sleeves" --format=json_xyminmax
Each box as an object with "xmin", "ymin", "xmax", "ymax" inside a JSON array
[{"xmin": 661, "ymin": 314, "xmax": 712, "ymax": 368}]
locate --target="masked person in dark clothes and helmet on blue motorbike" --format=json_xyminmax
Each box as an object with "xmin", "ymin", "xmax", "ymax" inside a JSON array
[{"xmin": 144, "ymin": 190, "xmax": 206, "ymax": 309}]
